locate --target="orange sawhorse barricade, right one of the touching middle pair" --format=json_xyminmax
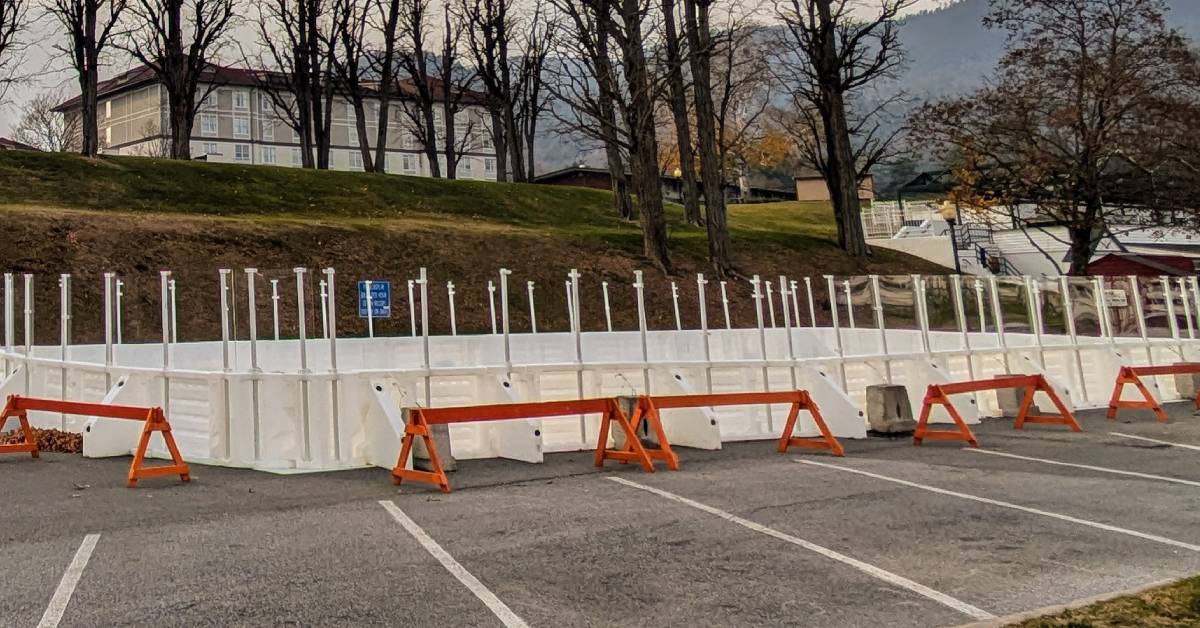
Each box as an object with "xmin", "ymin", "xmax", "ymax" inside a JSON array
[{"xmin": 632, "ymin": 390, "xmax": 846, "ymax": 458}]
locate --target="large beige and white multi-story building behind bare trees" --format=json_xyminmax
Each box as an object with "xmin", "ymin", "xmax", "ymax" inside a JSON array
[{"xmin": 55, "ymin": 66, "xmax": 496, "ymax": 179}]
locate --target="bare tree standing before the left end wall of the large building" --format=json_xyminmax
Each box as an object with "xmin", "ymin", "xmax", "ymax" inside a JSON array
[{"xmin": 122, "ymin": 0, "xmax": 236, "ymax": 160}]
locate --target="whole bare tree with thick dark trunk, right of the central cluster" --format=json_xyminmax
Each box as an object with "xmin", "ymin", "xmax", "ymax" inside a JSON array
[{"xmin": 773, "ymin": 0, "xmax": 916, "ymax": 257}]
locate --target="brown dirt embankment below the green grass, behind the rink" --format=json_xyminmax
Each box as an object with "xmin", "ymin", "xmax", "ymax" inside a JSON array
[{"xmin": 0, "ymin": 207, "xmax": 942, "ymax": 343}]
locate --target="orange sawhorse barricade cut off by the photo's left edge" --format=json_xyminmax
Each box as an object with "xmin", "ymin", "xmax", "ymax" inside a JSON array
[{"xmin": 0, "ymin": 395, "xmax": 192, "ymax": 489}]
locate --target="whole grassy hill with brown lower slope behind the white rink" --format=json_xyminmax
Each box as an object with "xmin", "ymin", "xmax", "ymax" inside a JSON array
[{"xmin": 0, "ymin": 151, "xmax": 944, "ymax": 340}]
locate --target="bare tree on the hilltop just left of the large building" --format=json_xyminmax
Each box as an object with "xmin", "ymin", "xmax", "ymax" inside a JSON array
[{"xmin": 48, "ymin": 0, "xmax": 128, "ymax": 157}]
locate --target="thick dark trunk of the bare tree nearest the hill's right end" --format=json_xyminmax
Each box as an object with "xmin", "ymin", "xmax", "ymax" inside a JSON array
[{"xmin": 823, "ymin": 88, "xmax": 870, "ymax": 258}]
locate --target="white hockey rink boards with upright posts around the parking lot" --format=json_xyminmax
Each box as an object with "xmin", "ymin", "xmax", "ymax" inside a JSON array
[{"xmin": 0, "ymin": 269, "xmax": 1200, "ymax": 472}]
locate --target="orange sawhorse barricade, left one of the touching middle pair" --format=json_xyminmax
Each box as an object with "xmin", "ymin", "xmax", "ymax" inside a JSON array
[{"xmin": 391, "ymin": 399, "xmax": 674, "ymax": 492}]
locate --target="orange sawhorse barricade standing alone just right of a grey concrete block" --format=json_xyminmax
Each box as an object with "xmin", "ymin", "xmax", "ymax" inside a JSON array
[{"xmin": 912, "ymin": 375, "xmax": 1081, "ymax": 447}]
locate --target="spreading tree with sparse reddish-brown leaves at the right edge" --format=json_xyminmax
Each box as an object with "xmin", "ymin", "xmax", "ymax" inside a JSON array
[{"xmin": 913, "ymin": 0, "xmax": 1200, "ymax": 275}]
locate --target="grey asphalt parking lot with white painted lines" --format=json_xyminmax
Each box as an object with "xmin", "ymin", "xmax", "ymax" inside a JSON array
[{"xmin": 0, "ymin": 403, "xmax": 1200, "ymax": 627}]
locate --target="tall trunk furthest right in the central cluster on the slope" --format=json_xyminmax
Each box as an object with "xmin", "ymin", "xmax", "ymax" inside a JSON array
[{"xmin": 684, "ymin": 0, "xmax": 734, "ymax": 277}]
